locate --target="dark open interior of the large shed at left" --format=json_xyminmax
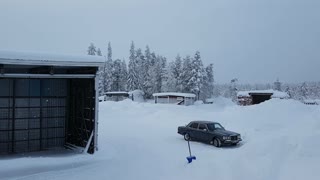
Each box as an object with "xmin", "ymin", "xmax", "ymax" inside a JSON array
[{"xmin": 0, "ymin": 78, "xmax": 95, "ymax": 154}]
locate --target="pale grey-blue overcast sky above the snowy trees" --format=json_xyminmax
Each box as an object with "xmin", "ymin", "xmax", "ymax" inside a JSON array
[{"xmin": 0, "ymin": 0, "xmax": 320, "ymax": 83}]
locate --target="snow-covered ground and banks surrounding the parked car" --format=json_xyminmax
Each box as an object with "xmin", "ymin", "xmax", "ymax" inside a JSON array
[{"xmin": 0, "ymin": 98, "xmax": 320, "ymax": 180}]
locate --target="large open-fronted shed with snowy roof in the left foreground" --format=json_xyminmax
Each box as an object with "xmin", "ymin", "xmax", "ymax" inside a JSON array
[{"xmin": 0, "ymin": 51, "xmax": 104, "ymax": 154}]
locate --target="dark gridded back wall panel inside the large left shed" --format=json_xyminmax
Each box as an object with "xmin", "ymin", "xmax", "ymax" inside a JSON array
[{"xmin": 0, "ymin": 79, "xmax": 68, "ymax": 154}]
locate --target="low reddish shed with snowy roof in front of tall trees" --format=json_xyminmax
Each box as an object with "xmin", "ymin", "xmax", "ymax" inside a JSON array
[{"xmin": 153, "ymin": 92, "xmax": 196, "ymax": 106}]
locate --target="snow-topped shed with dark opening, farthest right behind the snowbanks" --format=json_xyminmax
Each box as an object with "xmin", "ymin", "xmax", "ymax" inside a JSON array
[{"xmin": 237, "ymin": 90, "xmax": 289, "ymax": 106}]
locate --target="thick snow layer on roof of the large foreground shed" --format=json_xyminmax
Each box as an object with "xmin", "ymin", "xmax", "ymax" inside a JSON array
[{"xmin": 0, "ymin": 50, "xmax": 105, "ymax": 67}]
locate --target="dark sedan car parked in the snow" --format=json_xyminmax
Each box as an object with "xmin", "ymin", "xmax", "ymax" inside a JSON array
[{"xmin": 178, "ymin": 121, "xmax": 242, "ymax": 147}]
